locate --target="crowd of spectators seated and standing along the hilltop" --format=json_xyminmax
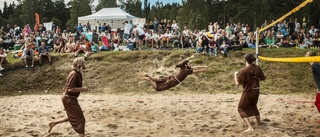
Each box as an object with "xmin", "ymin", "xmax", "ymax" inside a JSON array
[{"xmin": 0, "ymin": 18, "xmax": 320, "ymax": 76}]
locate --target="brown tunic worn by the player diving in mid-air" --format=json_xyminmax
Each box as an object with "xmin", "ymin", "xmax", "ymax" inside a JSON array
[{"xmin": 156, "ymin": 68, "xmax": 193, "ymax": 91}]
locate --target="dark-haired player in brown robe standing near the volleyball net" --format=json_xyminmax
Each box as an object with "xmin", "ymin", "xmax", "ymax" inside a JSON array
[{"xmin": 235, "ymin": 53, "xmax": 266, "ymax": 132}]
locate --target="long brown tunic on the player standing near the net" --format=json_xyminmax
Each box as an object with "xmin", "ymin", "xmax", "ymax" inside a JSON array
[{"xmin": 237, "ymin": 64, "xmax": 266, "ymax": 118}]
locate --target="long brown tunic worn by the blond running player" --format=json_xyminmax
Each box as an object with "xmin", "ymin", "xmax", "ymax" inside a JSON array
[{"xmin": 62, "ymin": 70, "xmax": 85, "ymax": 134}]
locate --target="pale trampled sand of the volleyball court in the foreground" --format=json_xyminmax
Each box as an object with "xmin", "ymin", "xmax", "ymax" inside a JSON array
[{"xmin": 0, "ymin": 92, "xmax": 320, "ymax": 137}]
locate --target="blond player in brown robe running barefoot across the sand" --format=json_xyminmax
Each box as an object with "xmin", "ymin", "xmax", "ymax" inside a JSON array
[{"xmin": 48, "ymin": 57, "xmax": 88, "ymax": 137}]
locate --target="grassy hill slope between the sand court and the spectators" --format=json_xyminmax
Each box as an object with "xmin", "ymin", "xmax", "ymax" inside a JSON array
[{"xmin": 0, "ymin": 48, "xmax": 316, "ymax": 95}]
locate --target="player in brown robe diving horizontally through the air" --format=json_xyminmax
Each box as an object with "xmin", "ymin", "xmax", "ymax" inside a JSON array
[{"xmin": 143, "ymin": 60, "xmax": 208, "ymax": 91}]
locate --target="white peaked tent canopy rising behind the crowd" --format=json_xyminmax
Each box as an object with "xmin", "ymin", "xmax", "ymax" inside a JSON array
[{"xmin": 78, "ymin": 7, "xmax": 139, "ymax": 28}]
